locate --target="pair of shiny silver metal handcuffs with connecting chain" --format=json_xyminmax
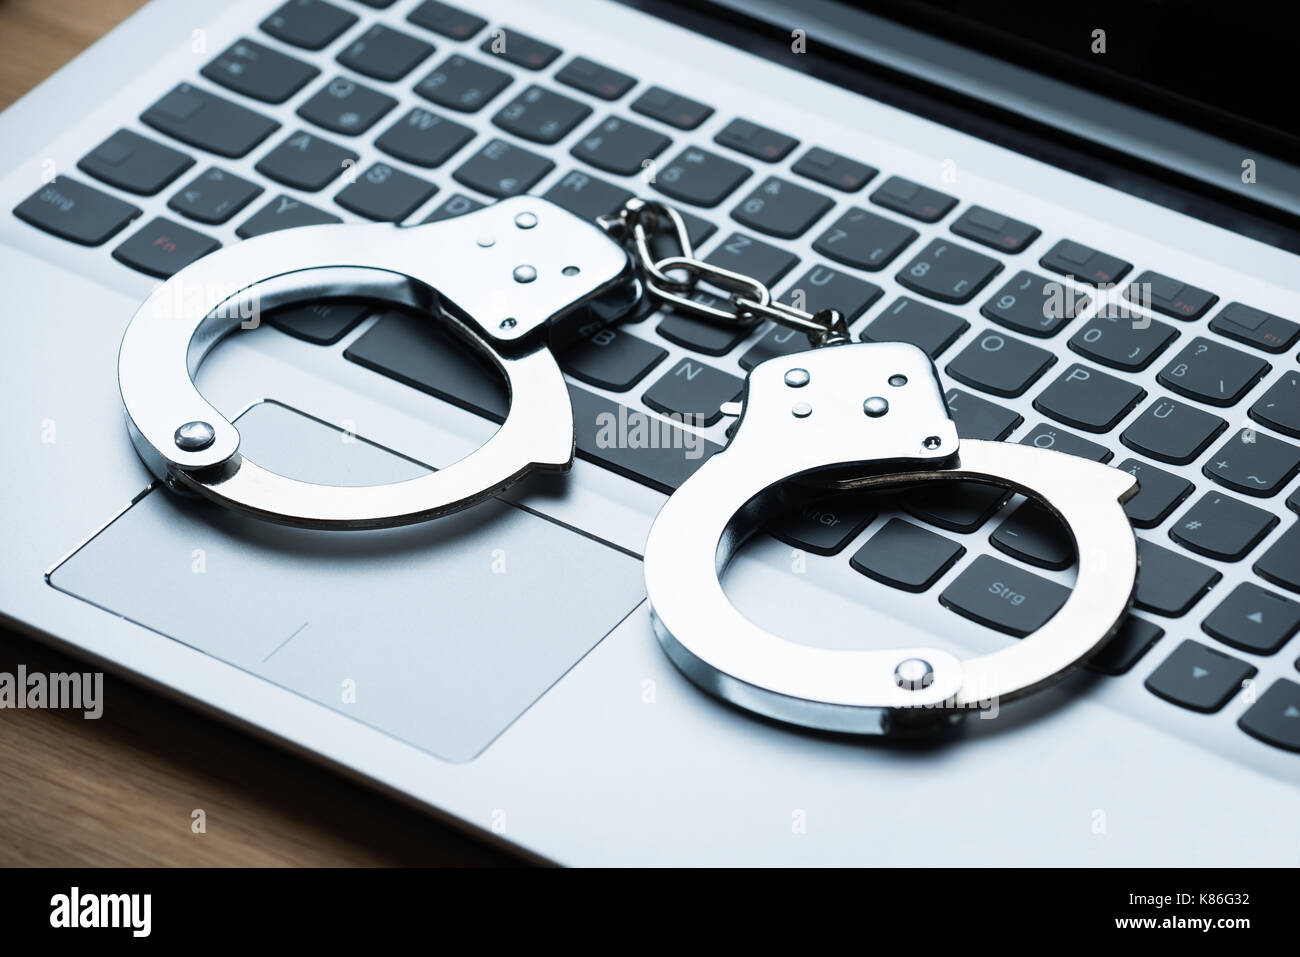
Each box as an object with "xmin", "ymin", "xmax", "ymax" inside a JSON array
[{"xmin": 118, "ymin": 196, "xmax": 1138, "ymax": 735}]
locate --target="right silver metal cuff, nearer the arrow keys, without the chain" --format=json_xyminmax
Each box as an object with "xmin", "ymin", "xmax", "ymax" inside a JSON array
[{"xmin": 645, "ymin": 343, "xmax": 1138, "ymax": 735}]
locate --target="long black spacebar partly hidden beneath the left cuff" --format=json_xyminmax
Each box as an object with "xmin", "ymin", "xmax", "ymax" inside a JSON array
[{"xmin": 343, "ymin": 316, "xmax": 722, "ymax": 494}]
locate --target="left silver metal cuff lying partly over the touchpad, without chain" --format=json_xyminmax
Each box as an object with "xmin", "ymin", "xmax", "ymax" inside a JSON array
[{"xmin": 118, "ymin": 196, "xmax": 640, "ymax": 528}]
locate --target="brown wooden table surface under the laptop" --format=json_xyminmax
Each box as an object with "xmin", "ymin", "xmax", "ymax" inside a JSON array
[{"xmin": 0, "ymin": 0, "xmax": 515, "ymax": 866}]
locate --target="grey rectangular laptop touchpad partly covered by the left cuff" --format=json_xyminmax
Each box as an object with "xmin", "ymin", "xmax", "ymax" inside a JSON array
[{"xmin": 51, "ymin": 403, "xmax": 644, "ymax": 761}]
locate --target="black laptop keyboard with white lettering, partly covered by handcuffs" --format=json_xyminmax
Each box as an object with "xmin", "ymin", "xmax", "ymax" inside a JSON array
[{"xmin": 13, "ymin": 0, "xmax": 1300, "ymax": 752}]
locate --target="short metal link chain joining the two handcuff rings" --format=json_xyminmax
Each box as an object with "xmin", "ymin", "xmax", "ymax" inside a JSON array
[{"xmin": 597, "ymin": 196, "xmax": 852, "ymax": 347}]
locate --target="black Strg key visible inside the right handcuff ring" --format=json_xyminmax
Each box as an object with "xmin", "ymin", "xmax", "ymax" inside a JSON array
[{"xmin": 939, "ymin": 555, "xmax": 1070, "ymax": 638}]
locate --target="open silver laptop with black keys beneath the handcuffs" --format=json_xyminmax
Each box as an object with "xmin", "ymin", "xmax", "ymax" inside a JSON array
[{"xmin": 0, "ymin": 0, "xmax": 1300, "ymax": 865}]
